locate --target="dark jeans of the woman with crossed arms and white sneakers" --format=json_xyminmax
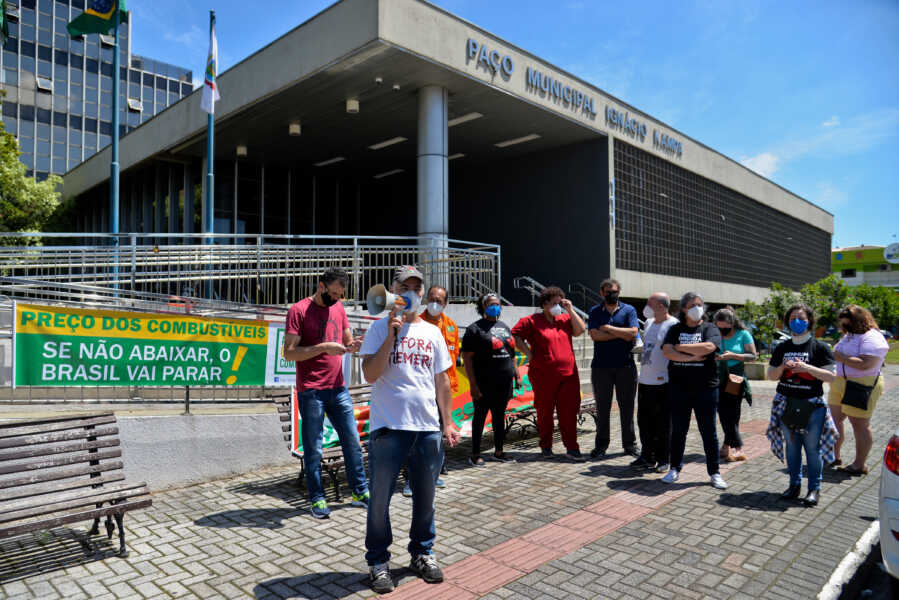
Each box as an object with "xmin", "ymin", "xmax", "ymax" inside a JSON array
[{"xmin": 668, "ymin": 383, "xmax": 718, "ymax": 475}]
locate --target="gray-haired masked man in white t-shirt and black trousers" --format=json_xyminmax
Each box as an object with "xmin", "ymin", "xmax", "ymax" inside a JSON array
[{"xmin": 637, "ymin": 292, "xmax": 677, "ymax": 473}]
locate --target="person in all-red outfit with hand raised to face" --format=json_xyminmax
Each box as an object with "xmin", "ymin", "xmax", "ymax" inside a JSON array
[{"xmin": 512, "ymin": 287, "xmax": 587, "ymax": 462}]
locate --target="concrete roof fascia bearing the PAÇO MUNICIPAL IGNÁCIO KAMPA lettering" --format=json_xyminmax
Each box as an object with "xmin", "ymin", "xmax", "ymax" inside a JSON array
[{"xmin": 378, "ymin": 0, "xmax": 833, "ymax": 233}]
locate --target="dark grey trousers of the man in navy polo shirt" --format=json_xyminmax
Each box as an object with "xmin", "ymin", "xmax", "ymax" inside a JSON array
[{"xmin": 592, "ymin": 363, "xmax": 637, "ymax": 450}]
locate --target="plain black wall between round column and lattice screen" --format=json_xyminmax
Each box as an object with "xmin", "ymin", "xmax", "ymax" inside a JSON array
[{"xmin": 450, "ymin": 139, "xmax": 609, "ymax": 304}]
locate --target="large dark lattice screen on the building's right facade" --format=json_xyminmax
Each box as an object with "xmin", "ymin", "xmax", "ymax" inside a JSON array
[{"xmin": 614, "ymin": 140, "xmax": 831, "ymax": 288}]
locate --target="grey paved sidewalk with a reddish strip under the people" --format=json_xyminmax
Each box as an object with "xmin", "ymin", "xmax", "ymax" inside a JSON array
[{"xmin": 0, "ymin": 367, "xmax": 899, "ymax": 600}]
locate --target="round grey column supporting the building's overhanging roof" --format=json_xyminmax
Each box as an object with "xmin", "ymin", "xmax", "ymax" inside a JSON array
[{"xmin": 417, "ymin": 85, "xmax": 452, "ymax": 294}]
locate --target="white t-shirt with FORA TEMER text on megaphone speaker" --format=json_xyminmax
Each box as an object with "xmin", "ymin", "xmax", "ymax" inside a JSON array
[{"xmin": 359, "ymin": 317, "xmax": 452, "ymax": 431}]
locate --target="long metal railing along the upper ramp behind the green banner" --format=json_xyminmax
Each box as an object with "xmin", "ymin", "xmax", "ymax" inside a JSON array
[{"xmin": 0, "ymin": 233, "xmax": 502, "ymax": 305}]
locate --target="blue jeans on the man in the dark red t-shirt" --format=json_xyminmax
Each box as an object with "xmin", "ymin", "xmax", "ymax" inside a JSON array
[{"xmin": 297, "ymin": 387, "xmax": 368, "ymax": 502}]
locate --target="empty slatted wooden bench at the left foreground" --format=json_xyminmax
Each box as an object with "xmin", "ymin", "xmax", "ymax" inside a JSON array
[{"xmin": 0, "ymin": 413, "xmax": 153, "ymax": 557}]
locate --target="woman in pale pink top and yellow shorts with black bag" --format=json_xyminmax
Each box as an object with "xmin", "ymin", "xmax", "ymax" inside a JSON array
[{"xmin": 827, "ymin": 304, "xmax": 890, "ymax": 475}]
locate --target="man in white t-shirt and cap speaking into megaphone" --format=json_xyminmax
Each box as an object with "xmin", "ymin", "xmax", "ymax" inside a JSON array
[{"xmin": 360, "ymin": 266, "xmax": 460, "ymax": 593}]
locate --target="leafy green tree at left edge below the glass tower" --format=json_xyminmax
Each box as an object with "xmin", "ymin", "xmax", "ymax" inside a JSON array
[{"xmin": 0, "ymin": 94, "xmax": 62, "ymax": 246}]
